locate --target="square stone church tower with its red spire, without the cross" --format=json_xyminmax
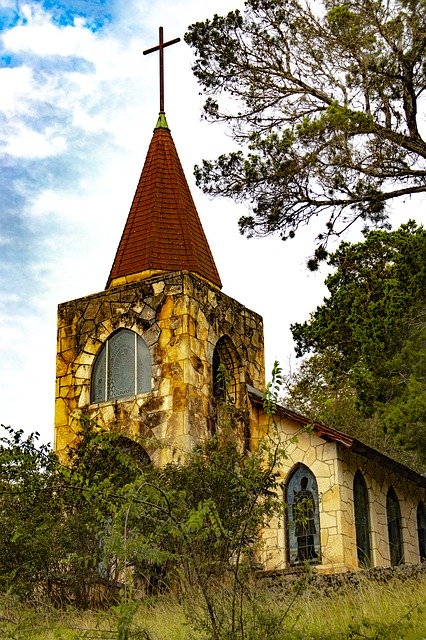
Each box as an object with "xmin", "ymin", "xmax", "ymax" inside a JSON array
[{"xmin": 55, "ymin": 112, "xmax": 265, "ymax": 464}]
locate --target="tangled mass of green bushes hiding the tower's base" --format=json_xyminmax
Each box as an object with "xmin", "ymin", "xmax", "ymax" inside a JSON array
[{"xmin": 0, "ymin": 376, "xmax": 285, "ymax": 640}]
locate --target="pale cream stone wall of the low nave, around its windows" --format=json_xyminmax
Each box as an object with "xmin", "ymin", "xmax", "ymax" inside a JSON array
[{"xmin": 252, "ymin": 411, "xmax": 425, "ymax": 574}]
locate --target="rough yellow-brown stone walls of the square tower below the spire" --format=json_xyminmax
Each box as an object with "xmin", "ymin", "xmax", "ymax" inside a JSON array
[{"xmin": 55, "ymin": 272, "xmax": 265, "ymax": 464}]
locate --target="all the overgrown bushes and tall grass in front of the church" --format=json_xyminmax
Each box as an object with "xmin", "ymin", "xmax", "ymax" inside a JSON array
[{"xmin": 0, "ymin": 365, "xmax": 426, "ymax": 640}]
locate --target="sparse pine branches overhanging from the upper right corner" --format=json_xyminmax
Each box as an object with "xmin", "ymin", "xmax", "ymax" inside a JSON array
[{"xmin": 185, "ymin": 0, "xmax": 426, "ymax": 268}]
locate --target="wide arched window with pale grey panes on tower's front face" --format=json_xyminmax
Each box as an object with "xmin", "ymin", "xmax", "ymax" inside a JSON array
[{"xmin": 90, "ymin": 329, "xmax": 151, "ymax": 402}]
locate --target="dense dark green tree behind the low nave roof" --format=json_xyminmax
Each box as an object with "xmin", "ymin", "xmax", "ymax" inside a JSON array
[{"xmin": 291, "ymin": 222, "xmax": 426, "ymax": 463}]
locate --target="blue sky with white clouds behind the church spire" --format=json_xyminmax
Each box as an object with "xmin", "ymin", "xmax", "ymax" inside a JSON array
[{"xmin": 0, "ymin": 0, "xmax": 422, "ymax": 442}]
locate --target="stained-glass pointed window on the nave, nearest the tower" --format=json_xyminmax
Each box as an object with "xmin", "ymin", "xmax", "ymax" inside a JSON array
[{"xmin": 285, "ymin": 464, "xmax": 321, "ymax": 566}]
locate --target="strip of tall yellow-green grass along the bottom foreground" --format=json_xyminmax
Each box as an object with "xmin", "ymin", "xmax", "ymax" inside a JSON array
[{"xmin": 0, "ymin": 575, "xmax": 426, "ymax": 640}]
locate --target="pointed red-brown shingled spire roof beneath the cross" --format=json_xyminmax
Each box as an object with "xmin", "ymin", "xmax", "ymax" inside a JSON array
[{"xmin": 107, "ymin": 114, "xmax": 222, "ymax": 288}]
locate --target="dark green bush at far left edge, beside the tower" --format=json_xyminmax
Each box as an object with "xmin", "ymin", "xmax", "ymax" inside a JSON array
[{"xmin": 0, "ymin": 425, "xmax": 60, "ymax": 596}]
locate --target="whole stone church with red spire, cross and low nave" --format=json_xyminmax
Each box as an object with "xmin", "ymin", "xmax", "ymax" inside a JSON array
[{"xmin": 55, "ymin": 33, "xmax": 426, "ymax": 573}]
